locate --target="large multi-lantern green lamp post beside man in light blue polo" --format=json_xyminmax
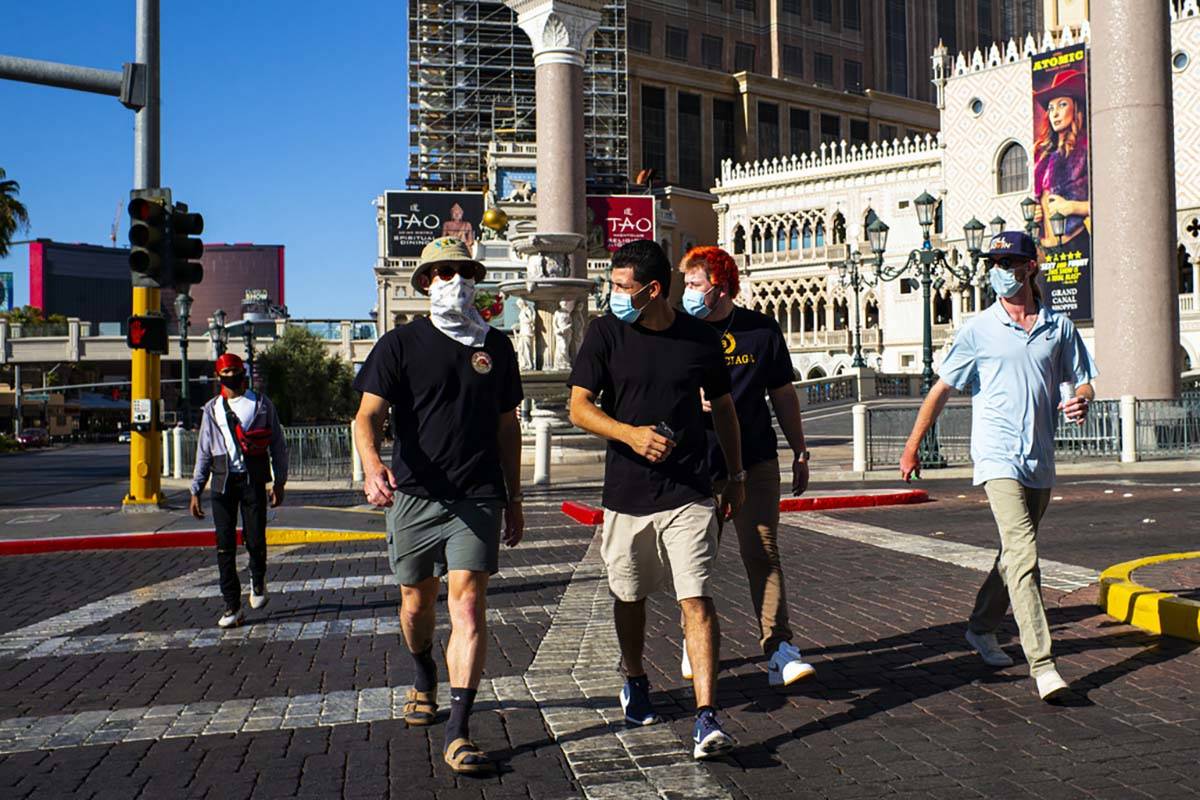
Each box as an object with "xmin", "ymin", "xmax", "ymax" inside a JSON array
[{"xmin": 866, "ymin": 192, "xmax": 988, "ymax": 468}]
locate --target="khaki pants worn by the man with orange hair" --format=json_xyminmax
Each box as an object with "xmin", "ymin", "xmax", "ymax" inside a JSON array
[{"xmin": 713, "ymin": 458, "xmax": 792, "ymax": 655}]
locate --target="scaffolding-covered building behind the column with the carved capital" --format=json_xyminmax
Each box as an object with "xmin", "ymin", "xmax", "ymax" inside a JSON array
[{"xmin": 408, "ymin": 0, "xmax": 629, "ymax": 192}]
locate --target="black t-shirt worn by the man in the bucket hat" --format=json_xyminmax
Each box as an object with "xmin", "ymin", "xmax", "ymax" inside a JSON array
[{"xmin": 354, "ymin": 317, "xmax": 523, "ymax": 500}]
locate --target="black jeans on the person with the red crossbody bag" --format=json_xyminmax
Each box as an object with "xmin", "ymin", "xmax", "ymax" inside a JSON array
[{"xmin": 212, "ymin": 473, "xmax": 266, "ymax": 608}]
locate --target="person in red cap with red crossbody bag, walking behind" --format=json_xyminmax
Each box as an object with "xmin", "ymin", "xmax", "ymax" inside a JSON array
[{"xmin": 191, "ymin": 353, "xmax": 288, "ymax": 627}]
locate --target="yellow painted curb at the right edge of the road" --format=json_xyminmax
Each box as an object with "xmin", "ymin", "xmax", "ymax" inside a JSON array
[{"xmin": 1100, "ymin": 551, "xmax": 1200, "ymax": 642}]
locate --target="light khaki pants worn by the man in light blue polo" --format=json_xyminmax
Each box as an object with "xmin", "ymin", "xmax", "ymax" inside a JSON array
[{"xmin": 968, "ymin": 479, "xmax": 1054, "ymax": 678}]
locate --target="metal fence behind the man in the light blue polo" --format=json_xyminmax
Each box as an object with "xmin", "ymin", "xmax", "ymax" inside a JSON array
[{"xmin": 866, "ymin": 401, "xmax": 1128, "ymax": 469}]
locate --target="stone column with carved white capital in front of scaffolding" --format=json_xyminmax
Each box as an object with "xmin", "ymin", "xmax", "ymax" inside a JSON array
[{"xmin": 505, "ymin": 0, "xmax": 604, "ymax": 278}]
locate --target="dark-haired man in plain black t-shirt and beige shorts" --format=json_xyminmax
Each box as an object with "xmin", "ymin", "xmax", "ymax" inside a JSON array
[{"xmin": 569, "ymin": 241, "xmax": 745, "ymax": 758}]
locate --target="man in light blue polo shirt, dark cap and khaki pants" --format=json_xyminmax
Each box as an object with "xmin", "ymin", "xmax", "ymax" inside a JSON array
[{"xmin": 900, "ymin": 230, "xmax": 1097, "ymax": 700}]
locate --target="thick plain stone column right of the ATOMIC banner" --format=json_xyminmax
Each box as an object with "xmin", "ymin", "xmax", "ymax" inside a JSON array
[{"xmin": 1091, "ymin": 0, "xmax": 1180, "ymax": 398}]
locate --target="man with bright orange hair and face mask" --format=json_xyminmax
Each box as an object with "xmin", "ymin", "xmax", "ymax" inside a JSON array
[{"xmin": 679, "ymin": 247, "xmax": 815, "ymax": 686}]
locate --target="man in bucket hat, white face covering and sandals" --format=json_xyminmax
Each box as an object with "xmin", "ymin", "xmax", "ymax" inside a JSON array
[{"xmin": 354, "ymin": 237, "xmax": 524, "ymax": 774}]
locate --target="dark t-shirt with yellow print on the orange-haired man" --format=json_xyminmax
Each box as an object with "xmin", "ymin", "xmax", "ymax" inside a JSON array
[{"xmin": 704, "ymin": 307, "xmax": 793, "ymax": 481}]
